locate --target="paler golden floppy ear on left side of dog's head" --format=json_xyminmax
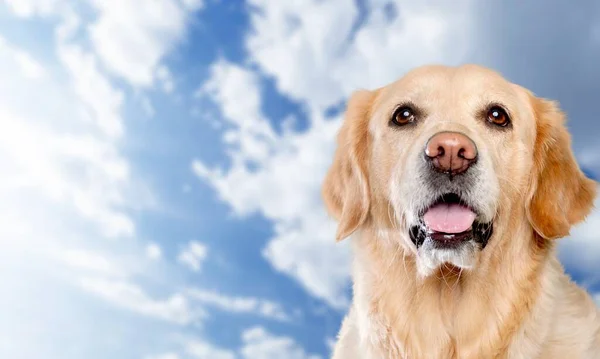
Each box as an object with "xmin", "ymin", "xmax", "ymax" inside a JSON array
[{"xmin": 321, "ymin": 90, "xmax": 375, "ymax": 241}]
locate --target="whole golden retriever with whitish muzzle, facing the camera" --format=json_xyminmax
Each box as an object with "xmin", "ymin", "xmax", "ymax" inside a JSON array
[{"xmin": 322, "ymin": 65, "xmax": 600, "ymax": 359}]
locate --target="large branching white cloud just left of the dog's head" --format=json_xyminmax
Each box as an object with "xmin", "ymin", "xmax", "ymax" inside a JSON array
[{"xmin": 192, "ymin": 61, "xmax": 349, "ymax": 307}]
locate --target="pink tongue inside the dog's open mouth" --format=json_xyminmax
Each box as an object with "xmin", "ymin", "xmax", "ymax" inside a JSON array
[{"xmin": 423, "ymin": 203, "xmax": 475, "ymax": 233}]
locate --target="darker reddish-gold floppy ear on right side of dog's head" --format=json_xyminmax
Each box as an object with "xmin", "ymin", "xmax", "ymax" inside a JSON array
[{"xmin": 527, "ymin": 95, "xmax": 597, "ymax": 239}]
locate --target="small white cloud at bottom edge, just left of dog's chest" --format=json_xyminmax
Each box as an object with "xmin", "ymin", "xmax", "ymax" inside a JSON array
[{"xmin": 240, "ymin": 327, "xmax": 320, "ymax": 359}]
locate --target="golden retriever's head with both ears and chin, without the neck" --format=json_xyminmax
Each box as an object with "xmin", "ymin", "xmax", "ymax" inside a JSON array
[{"xmin": 322, "ymin": 65, "xmax": 596, "ymax": 275}]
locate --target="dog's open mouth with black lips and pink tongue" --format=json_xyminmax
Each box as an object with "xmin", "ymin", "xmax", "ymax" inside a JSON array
[{"xmin": 410, "ymin": 193, "xmax": 492, "ymax": 248}]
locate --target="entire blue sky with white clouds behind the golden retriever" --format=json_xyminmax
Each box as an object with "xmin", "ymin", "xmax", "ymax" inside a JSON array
[{"xmin": 0, "ymin": 0, "xmax": 600, "ymax": 359}]
